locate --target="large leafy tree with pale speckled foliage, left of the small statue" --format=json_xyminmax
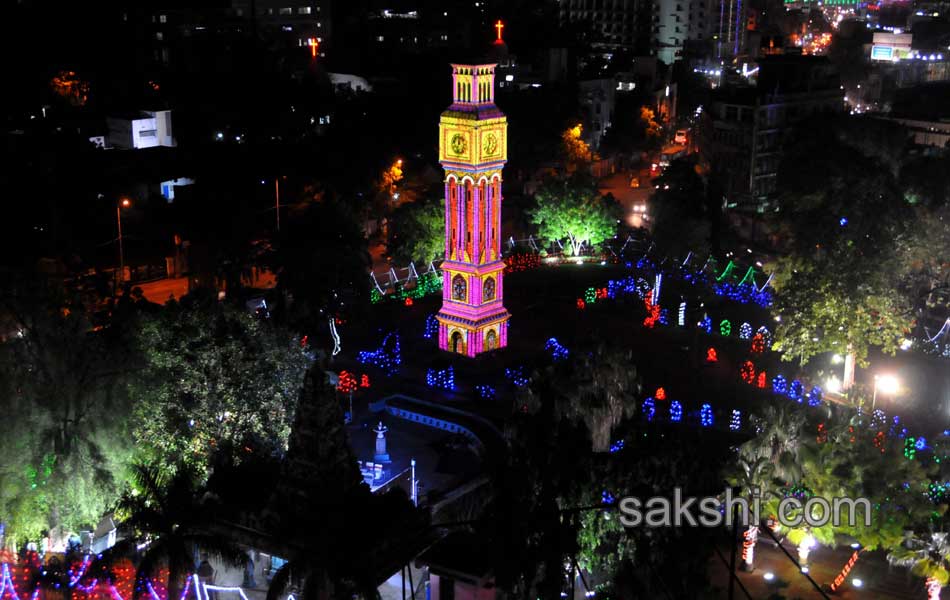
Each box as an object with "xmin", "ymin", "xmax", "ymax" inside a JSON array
[{"xmin": 132, "ymin": 296, "xmax": 310, "ymax": 469}]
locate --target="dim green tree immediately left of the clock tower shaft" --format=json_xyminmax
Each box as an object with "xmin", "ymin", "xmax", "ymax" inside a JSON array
[{"xmin": 389, "ymin": 200, "xmax": 445, "ymax": 265}]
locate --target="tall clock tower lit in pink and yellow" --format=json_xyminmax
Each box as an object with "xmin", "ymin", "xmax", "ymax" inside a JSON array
[{"xmin": 436, "ymin": 64, "xmax": 510, "ymax": 356}]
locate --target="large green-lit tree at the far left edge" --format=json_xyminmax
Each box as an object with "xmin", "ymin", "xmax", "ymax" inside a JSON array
[{"xmin": 0, "ymin": 279, "xmax": 133, "ymax": 540}]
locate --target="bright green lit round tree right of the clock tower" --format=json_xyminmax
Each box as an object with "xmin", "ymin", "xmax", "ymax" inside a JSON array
[{"xmin": 529, "ymin": 175, "xmax": 620, "ymax": 256}]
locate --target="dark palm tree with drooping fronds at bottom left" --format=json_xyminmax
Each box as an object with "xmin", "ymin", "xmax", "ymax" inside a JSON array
[{"xmin": 107, "ymin": 463, "xmax": 247, "ymax": 600}]
